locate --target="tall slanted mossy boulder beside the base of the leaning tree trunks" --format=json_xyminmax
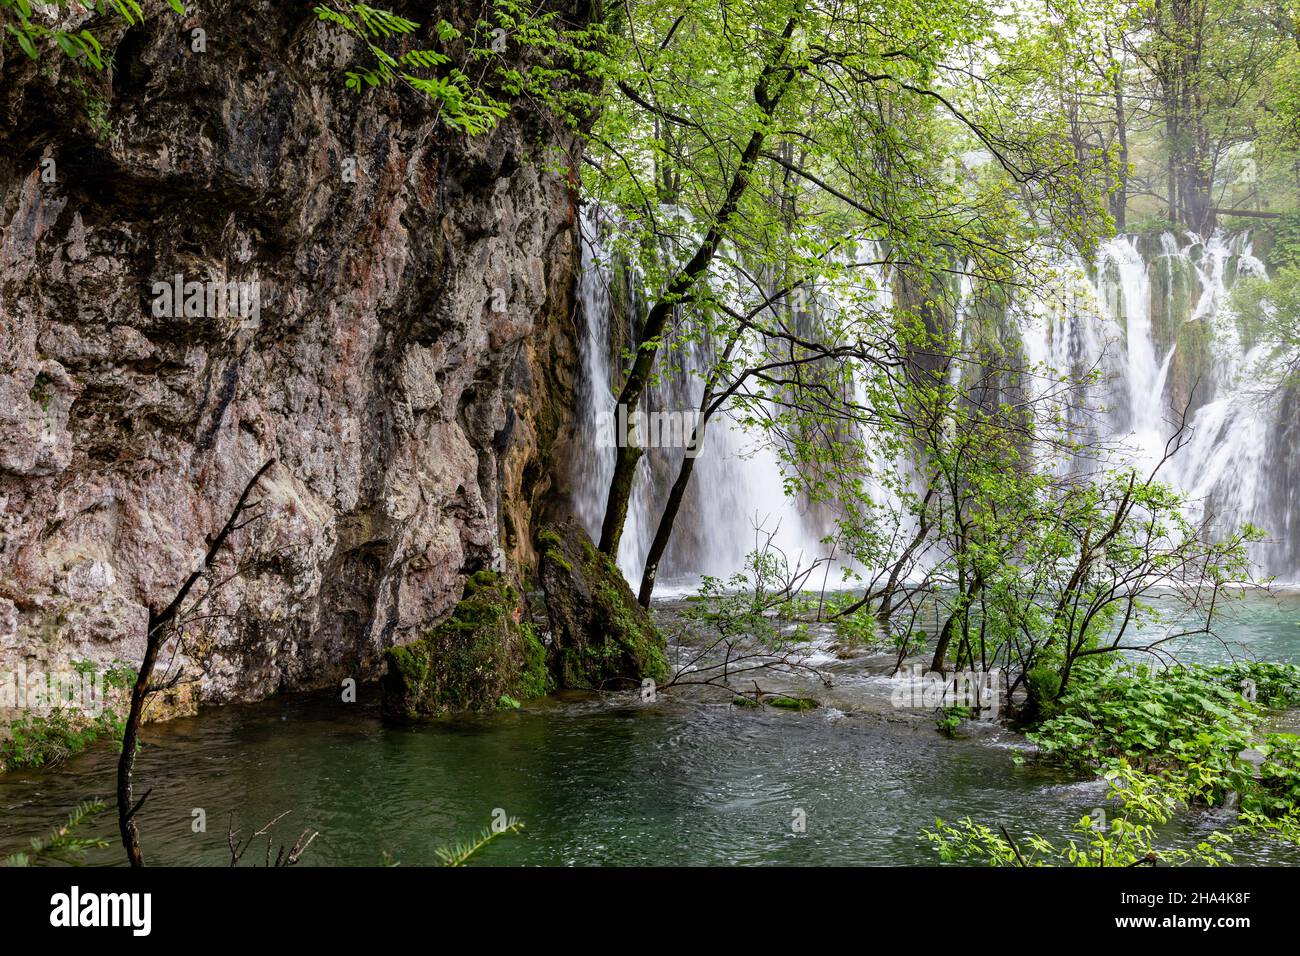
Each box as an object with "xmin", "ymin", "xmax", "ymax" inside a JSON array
[{"xmin": 537, "ymin": 520, "xmax": 668, "ymax": 689}]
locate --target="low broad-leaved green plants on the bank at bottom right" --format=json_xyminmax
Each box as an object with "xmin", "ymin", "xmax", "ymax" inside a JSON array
[{"xmin": 924, "ymin": 662, "xmax": 1300, "ymax": 866}]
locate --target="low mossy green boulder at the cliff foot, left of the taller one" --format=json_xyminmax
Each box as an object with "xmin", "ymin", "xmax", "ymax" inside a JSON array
[{"xmin": 384, "ymin": 571, "xmax": 551, "ymax": 719}]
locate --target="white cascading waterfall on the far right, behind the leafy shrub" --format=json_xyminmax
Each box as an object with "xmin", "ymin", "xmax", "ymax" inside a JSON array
[{"xmin": 1022, "ymin": 233, "xmax": 1300, "ymax": 581}]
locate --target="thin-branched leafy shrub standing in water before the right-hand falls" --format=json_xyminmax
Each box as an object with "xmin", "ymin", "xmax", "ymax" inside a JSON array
[{"xmin": 806, "ymin": 308, "xmax": 1261, "ymax": 722}]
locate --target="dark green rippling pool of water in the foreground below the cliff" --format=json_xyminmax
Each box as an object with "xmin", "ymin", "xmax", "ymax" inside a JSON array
[{"xmin": 0, "ymin": 598, "xmax": 1300, "ymax": 865}]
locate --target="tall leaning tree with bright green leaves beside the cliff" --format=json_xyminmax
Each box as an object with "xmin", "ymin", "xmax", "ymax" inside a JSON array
[{"xmin": 584, "ymin": 0, "xmax": 1107, "ymax": 574}]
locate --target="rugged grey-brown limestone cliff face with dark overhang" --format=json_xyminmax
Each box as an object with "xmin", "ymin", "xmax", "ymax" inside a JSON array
[{"xmin": 0, "ymin": 0, "xmax": 579, "ymax": 701}]
